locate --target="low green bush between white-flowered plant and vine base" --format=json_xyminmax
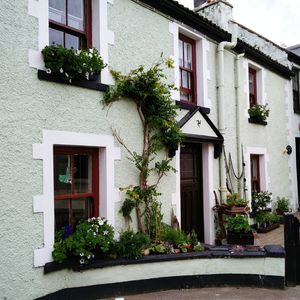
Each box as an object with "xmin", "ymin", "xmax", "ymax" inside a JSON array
[{"xmin": 115, "ymin": 230, "xmax": 151, "ymax": 259}]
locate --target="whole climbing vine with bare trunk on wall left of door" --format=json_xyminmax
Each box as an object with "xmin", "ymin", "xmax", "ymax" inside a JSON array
[{"xmin": 103, "ymin": 56, "xmax": 182, "ymax": 239}]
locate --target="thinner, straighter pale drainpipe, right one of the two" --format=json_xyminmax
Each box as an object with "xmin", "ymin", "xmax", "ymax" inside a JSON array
[{"xmin": 235, "ymin": 53, "xmax": 245, "ymax": 195}]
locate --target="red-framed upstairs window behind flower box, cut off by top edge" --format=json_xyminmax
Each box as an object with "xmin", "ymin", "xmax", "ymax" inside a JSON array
[{"xmin": 49, "ymin": 0, "xmax": 92, "ymax": 49}]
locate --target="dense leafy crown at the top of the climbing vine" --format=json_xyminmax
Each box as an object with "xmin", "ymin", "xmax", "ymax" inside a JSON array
[{"xmin": 103, "ymin": 59, "xmax": 182, "ymax": 152}]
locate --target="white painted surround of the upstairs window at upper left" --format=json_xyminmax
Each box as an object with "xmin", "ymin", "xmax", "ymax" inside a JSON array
[{"xmin": 28, "ymin": 0, "xmax": 114, "ymax": 84}]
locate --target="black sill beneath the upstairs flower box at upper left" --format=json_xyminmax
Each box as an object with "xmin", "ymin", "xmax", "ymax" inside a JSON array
[{"xmin": 38, "ymin": 70, "xmax": 109, "ymax": 92}]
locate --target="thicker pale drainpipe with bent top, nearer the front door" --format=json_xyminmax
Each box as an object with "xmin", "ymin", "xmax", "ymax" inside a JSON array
[{"xmin": 217, "ymin": 24, "xmax": 237, "ymax": 203}]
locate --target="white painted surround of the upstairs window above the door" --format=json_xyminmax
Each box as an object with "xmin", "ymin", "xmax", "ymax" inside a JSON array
[{"xmin": 169, "ymin": 22, "xmax": 211, "ymax": 108}]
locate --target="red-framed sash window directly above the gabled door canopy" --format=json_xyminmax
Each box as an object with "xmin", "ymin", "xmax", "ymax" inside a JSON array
[{"xmin": 179, "ymin": 34, "xmax": 197, "ymax": 104}]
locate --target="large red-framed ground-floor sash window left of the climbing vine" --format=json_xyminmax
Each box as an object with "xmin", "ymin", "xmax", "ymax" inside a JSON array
[{"xmin": 53, "ymin": 147, "xmax": 99, "ymax": 230}]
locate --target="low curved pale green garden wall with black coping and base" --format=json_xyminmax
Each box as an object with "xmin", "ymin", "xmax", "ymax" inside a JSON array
[{"xmin": 38, "ymin": 246, "xmax": 285, "ymax": 299}]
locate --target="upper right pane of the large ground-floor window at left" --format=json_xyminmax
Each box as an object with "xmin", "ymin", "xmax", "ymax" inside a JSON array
[{"xmin": 74, "ymin": 154, "xmax": 92, "ymax": 193}]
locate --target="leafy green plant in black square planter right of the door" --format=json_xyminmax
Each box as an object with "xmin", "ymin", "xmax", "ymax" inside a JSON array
[{"xmin": 226, "ymin": 214, "xmax": 254, "ymax": 245}]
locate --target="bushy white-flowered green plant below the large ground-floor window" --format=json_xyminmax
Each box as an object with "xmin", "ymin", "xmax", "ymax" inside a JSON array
[{"xmin": 52, "ymin": 218, "xmax": 114, "ymax": 264}]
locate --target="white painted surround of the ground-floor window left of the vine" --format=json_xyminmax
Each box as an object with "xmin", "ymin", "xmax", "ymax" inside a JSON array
[{"xmin": 33, "ymin": 130, "xmax": 121, "ymax": 267}]
